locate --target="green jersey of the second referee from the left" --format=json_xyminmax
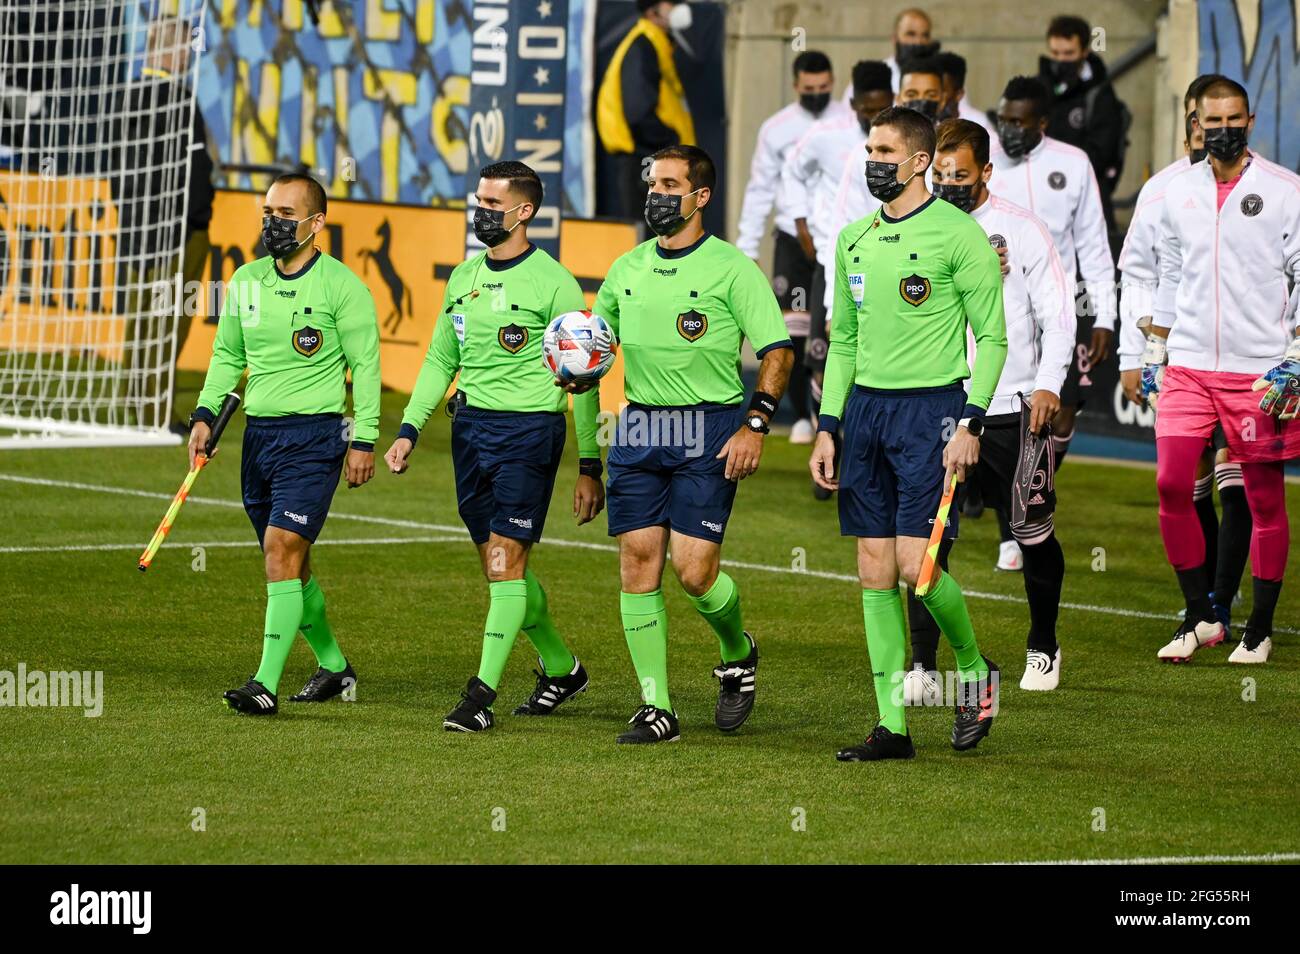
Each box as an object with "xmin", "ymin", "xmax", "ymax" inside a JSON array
[{"xmin": 402, "ymin": 246, "xmax": 601, "ymax": 458}]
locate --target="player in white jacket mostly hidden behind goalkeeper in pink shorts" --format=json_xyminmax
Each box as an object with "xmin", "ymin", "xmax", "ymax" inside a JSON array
[{"xmin": 1118, "ymin": 73, "xmax": 1251, "ymax": 626}]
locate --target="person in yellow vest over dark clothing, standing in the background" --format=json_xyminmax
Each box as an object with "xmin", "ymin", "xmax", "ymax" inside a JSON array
[{"xmin": 595, "ymin": 0, "xmax": 696, "ymax": 220}]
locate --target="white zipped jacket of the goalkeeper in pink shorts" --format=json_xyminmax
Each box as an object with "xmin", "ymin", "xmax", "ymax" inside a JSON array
[{"xmin": 1154, "ymin": 151, "xmax": 1300, "ymax": 374}]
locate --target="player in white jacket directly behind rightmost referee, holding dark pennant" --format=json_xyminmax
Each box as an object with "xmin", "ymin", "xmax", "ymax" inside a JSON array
[{"xmin": 904, "ymin": 118, "xmax": 1075, "ymax": 701}]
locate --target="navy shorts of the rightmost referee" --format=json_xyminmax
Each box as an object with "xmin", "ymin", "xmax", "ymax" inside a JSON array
[{"xmin": 839, "ymin": 382, "xmax": 966, "ymax": 539}]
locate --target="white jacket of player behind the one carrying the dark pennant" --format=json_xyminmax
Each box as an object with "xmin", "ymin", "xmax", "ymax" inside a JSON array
[{"xmin": 988, "ymin": 136, "xmax": 1115, "ymax": 330}]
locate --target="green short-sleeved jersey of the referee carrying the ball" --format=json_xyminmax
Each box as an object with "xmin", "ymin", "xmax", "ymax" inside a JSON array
[{"xmin": 592, "ymin": 236, "xmax": 790, "ymax": 407}]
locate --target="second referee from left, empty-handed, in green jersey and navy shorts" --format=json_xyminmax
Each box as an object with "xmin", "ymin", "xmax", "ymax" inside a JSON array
[{"xmin": 385, "ymin": 161, "xmax": 605, "ymax": 732}]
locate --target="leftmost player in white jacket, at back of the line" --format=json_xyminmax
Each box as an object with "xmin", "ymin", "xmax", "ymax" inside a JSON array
[{"xmin": 736, "ymin": 49, "xmax": 852, "ymax": 443}]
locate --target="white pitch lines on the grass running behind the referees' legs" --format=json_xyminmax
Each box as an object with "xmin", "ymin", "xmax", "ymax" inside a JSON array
[{"xmin": 0, "ymin": 473, "xmax": 1300, "ymax": 636}]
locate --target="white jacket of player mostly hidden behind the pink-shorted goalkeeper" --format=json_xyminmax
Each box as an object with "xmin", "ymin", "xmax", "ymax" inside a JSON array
[{"xmin": 1119, "ymin": 156, "xmax": 1192, "ymax": 370}]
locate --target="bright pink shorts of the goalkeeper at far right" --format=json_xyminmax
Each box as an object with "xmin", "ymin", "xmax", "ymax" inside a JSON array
[{"xmin": 1156, "ymin": 365, "xmax": 1300, "ymax": 463}]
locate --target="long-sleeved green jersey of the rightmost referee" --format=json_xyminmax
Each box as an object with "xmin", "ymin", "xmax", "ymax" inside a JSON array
[{"xmin": 822, "ymin": 198, "xmax": 1006, "ymax": 419}]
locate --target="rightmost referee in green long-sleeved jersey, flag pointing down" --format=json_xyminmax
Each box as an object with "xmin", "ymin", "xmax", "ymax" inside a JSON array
[{"xmin": 810, "ymin": 107, "xmax": 1006, "ymax": 762}]
